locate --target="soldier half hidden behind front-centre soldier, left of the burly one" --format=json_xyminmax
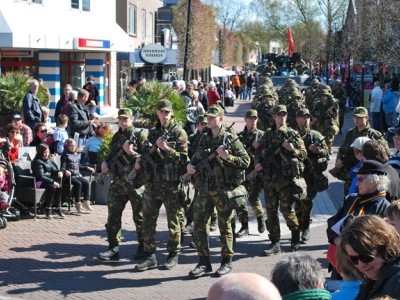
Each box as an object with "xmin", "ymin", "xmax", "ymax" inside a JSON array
[{"xmin": 236, "ymin": 109, "xmax": 265, "ymax": 238}]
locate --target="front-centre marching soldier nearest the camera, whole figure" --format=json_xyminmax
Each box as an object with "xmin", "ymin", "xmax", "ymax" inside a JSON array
[{"xmin": 187, "ymin": 106, "xmax": 250, "ymax": 278}]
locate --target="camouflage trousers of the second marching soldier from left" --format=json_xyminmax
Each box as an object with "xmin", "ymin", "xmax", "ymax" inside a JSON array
[{"xmin": 142, "ymin": 181, "xmax": 183, "ymax": 253}]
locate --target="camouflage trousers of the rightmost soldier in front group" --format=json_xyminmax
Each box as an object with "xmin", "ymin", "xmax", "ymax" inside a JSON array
[{"xmin": 295, "ymin": 174, "xmax": 317, "ymax": 230}]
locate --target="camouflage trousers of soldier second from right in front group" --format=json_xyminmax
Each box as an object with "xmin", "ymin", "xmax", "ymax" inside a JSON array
[{"xmin": 264, "ymin": 181, "xmax": 299, "ymax": 241}]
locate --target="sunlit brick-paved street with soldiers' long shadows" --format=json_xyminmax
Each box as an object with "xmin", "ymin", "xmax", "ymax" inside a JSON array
[{"xmin": 0, "ymin": 97, "xmax": 352, "ymax": 299}]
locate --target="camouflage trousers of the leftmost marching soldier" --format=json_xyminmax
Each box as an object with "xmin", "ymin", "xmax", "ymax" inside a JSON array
[{"xmin": 106, "ymin": 180, "xmax": 144, "ymax": 248}]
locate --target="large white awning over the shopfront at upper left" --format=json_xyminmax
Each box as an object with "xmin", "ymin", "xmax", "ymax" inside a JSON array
[{"xmin": 0, "ymin": 1, "xmax": 135, "ymax": 52}]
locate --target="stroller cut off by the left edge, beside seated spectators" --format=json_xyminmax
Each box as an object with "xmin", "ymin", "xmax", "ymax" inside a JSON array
[{"xmin": 0, "ymin": 157, "xmax": 20, "ymax": 229}]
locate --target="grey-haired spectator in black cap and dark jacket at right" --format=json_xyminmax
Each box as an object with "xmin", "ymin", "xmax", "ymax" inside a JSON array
[{"xmin": 326, "ymin": 160, "xmax": 390, "ymax": 279}]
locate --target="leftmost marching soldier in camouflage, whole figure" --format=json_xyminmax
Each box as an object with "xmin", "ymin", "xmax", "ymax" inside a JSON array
[{"xmin": 98, "ymin": 108, "xmax": 147, "ymax": 261}]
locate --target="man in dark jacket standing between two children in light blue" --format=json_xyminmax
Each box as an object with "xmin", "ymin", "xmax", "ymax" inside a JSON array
[{"xmin": 68, "ymin": 89, "xmax": 94, "ymax": 148}]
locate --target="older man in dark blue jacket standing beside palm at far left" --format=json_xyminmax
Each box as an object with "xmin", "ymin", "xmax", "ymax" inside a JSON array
[{"xmin": 22, "ymin": 79, "xmax": 44, "ymax": 130}]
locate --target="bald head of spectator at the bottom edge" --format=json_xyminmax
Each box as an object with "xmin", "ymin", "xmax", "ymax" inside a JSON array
[{"xmin": 207, "ymin": 273, "xmax": 282, "ymax": 300}]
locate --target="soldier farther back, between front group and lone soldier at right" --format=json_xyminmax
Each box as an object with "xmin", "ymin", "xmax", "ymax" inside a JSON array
[{"xmin": 311, "ymin": 86, "xmax": 339, "ymax": 153}]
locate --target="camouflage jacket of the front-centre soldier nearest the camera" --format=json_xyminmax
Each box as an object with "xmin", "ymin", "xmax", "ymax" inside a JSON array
[{"xmin": 190, "ymin": 126, "xmax": 250, "ymax": 191}]
